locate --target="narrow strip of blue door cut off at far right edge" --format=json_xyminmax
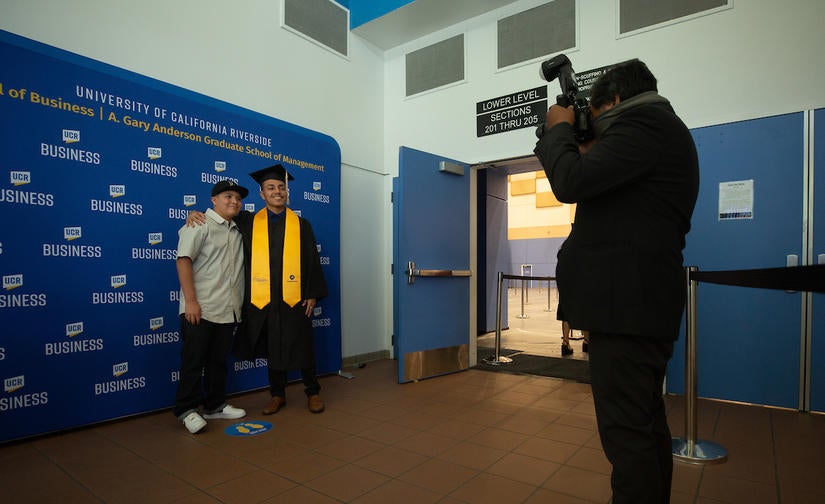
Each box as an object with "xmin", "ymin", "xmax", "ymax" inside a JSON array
[{"xmin": 808, "ymin": 109, "xmax": 825, "ymax": 412}]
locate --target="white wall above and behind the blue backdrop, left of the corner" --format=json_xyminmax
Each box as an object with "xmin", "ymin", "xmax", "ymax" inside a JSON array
[{"xmin": 0, "ymin": 0, "xmax": 392, "ymax": 357}]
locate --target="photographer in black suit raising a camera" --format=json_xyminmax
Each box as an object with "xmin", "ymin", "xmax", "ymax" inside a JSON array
[{"xmin": 535, "ymin": 60, "xmax": 699, "ymax": 504}]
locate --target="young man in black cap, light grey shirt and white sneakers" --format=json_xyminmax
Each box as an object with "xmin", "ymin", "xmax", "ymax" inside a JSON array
[{"xmin": 173, "ymin": 180, "xmax": 249, "ymax": 434}]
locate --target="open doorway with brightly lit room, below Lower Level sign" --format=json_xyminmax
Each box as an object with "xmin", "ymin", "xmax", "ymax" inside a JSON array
[{"xmin": 466, "ymin": 155, "xmax": 587, "ymax": 363}]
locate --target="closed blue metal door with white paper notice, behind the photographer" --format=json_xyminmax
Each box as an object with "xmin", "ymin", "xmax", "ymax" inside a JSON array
[{"xmin": 668, "ymin": 113, "xmax": 804, "ymax": 408}]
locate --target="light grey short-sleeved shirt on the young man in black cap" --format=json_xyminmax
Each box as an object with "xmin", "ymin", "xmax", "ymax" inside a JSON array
[{"xmin": 178, "ymin": 208, "xmax": 244, "ymax": 324}]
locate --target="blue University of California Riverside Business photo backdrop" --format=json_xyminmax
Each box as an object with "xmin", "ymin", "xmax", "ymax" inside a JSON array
[{"xmin": 0, "ymin": 31, "xmax": 341, "ymax": 442}]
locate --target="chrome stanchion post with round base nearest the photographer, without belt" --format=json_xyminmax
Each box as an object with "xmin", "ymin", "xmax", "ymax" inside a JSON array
[{"xmin": 671, "ymin": 266, "xmax": 728, "ymax": 464}]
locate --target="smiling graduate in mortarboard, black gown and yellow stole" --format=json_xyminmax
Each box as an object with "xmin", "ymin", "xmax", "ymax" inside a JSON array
[{"xmin": 187, "ymin": 164, "xmax": 327, "ymax": 415}]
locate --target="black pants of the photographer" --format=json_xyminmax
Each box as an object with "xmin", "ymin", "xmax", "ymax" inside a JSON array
[{"xmin": 590, "ymin": 333, "xmax": 673, "ymax": 504}]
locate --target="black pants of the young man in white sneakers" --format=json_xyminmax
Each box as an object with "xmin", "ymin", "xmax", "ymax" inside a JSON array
[{"xmin": 172, "ymin": 315, "xmax": 236, "ymax": 417}]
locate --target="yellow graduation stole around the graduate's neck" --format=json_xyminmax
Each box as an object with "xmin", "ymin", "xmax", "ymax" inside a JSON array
[{"xmin": 250, "ymin": 208, "xmax": 301, "ymax": 308}]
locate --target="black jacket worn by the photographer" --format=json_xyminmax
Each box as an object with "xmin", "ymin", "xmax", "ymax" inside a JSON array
[{"xmin": 535, "ymin": 103, "xmax": 699, "ymax": 340}]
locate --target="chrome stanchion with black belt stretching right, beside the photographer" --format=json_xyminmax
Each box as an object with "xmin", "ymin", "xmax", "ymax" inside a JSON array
[{"xmin": 672, "ymin": 264, "xmax": 825, "ymax": 464}]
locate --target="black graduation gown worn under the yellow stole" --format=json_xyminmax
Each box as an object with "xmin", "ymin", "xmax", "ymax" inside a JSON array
[{"xmin": 233, "ymin": 207, "xmax": 327, "ymax": 370}]
